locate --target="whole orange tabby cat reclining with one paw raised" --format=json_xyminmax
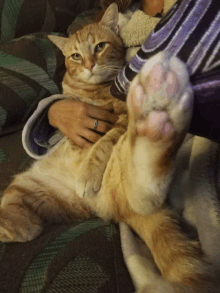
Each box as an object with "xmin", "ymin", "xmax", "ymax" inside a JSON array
[{"xmin": 0, "ymin": 4, "xmax": 218, "ymax": 293}]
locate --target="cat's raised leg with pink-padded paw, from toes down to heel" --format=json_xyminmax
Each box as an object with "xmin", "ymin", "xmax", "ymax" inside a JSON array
[{"xmin": 127, "ymin": 52, "xmax": 193, "ymax": 214}]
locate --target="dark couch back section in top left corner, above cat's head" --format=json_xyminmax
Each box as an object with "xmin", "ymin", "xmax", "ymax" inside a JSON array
[{"xmin": 0, "ymin": 0, "xmax": 99, "ymax": 42}]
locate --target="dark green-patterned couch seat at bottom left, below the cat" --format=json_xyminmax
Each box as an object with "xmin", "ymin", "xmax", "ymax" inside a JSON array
[{"xmin": 0, "ymin": 219, "xmax": 134, "ymax": 293}]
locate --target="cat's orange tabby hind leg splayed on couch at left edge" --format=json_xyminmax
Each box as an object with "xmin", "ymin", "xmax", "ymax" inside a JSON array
[{"xmin": 0, "ymin": 170, "xmax": 91, "ymax": 242}]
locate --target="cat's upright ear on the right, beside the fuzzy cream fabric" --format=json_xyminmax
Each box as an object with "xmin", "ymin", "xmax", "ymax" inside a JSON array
[{"xmin": 100, "ymin": 3, "xmax": 118, "ymax": 33}]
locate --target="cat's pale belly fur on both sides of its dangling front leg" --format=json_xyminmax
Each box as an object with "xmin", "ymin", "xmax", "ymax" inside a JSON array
[{"xmin": 26, "ymin": 131, "xmax": 129, "ymax": 219}]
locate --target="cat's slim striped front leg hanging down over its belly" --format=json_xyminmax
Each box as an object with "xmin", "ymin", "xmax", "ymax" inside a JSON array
[{"xmin": 76, "ymin": 114, "xmax": 127, "ymax": 198}]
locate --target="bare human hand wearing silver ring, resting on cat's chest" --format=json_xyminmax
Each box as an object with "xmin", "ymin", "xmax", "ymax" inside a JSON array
[{"xmin": 48, "ymin": 99, "xmax": 118, "ymax": 148}]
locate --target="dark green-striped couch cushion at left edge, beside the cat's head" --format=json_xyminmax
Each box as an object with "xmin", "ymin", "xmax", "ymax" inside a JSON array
[{"xmin": 0, "ymin": 34, "xmax": 65, "ymax": 135}]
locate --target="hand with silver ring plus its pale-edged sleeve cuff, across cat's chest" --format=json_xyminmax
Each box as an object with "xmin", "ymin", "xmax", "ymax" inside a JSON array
[{"xmin": 22, "ymin": 95, "xmax": 117, "ymax": 159}]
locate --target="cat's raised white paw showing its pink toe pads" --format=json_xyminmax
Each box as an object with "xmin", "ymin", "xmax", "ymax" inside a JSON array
[{"xmin": 128, "ymin": 52, "xmax": 193, "ymax": 143}]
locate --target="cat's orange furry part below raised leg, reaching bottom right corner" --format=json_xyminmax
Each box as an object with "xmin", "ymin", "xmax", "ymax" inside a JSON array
[{"xmin": 124, "ymin": 208, "xmax": 220, "ymax": 293}]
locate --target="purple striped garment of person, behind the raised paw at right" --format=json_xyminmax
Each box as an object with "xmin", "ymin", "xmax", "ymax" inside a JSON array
[{"xmin": 110, "ymin": 0, "xmax": 220, "ymax": 142}]
